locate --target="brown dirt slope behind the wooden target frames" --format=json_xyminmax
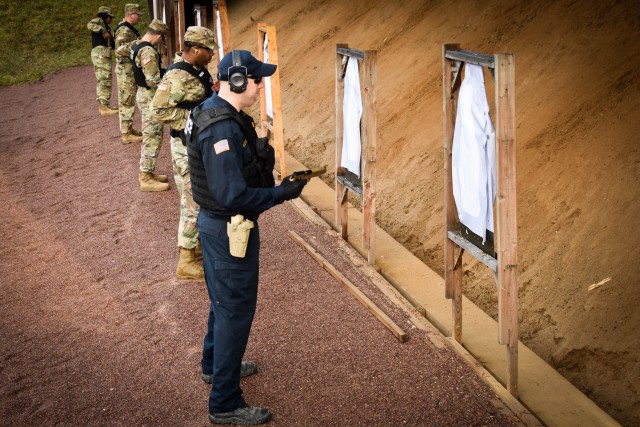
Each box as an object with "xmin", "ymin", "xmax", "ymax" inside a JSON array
[{"xmin": 229, "ymin": 0, "xmax": 640, "ymax": 425}]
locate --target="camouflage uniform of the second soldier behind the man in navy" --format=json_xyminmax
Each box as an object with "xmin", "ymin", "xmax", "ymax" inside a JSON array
[{"xmin": 131, "ymin": 20, "xmax": 166, "ymax": 172}]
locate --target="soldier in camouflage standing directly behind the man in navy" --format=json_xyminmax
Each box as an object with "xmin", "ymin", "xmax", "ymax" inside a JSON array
[{"xmin": 150, "ymin": 27, "xmax": 218, "ymax": 279}]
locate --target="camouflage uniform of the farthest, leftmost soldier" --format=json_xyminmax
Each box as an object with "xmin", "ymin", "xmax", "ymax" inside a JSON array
[{"xmin": 87, "ymin": 7, "xmax": 114, "ymax": 105}]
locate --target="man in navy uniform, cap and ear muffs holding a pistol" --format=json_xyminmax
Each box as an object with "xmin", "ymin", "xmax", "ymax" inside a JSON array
[{"xmin": 185, "ymin": 50, "xmax": 307, "ymax": 425}]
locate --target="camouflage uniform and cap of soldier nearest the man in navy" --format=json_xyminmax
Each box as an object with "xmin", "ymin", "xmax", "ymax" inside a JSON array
[{"xmin": 151, "ymin": 27, "xmax": 215, "ymax": 249}]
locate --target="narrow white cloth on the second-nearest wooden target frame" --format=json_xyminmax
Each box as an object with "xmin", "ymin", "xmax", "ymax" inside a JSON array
[{"xmin": 340, "ymin": 58, "xmax": 362, "ymax": 177}]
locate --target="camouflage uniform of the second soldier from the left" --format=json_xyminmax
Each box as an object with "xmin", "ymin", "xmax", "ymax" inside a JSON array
[{"xmin": 114, "ymin": 4, "xmax": 140, "ymax": 134}]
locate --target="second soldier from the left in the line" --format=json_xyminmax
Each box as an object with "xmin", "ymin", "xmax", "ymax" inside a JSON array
[{"xmin": 114, "ymin": 3, "xmax": 142, "ymax": 144}]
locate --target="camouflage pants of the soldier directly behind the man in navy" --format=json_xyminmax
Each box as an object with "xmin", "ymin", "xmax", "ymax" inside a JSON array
[{"xmin": 171, "ymin": 138, "xmax": 200, "ymax": 249}]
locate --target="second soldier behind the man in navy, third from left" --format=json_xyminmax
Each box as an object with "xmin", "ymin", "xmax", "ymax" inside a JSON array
[{"xmin": 131, "ymin": 19, "xmax": 169, "ymax": 191}]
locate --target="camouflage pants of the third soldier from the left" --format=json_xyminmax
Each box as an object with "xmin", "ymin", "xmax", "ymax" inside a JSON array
[{"xmin": 136, "ymin": 87, "xmax": 162, "ymax": 172}]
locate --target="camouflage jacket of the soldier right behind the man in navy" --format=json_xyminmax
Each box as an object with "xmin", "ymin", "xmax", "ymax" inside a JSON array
[{"xmin": 150, "ymin": 53, "xmax": 205, "ymax": 130}]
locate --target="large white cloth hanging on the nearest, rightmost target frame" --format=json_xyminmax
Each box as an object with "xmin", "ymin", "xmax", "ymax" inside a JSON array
[{"xmin": 451, "ymin": 64, "xmax": 496, "ymax": 243}]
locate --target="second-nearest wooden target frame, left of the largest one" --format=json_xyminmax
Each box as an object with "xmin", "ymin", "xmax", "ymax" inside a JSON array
[{"xmin": 335, "ymin": 44, "xmax": 378, "ymax": 265}]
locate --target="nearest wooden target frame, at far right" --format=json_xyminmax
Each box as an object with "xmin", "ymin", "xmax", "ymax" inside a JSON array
[{"xmin": 442, "ymin": 44, "xmax": 519, "ymax": 397}]
